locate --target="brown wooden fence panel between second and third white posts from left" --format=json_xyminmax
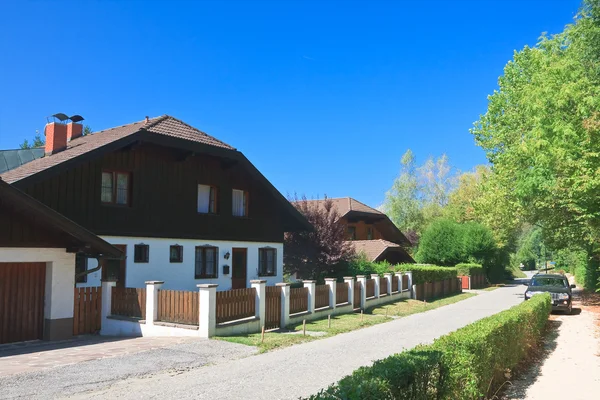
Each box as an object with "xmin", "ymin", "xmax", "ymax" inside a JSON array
[{"xmin": 156, "ymin": 289, "xmax": 200, "ymax": 325}]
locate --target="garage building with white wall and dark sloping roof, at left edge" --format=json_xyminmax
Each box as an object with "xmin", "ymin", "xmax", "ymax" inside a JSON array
[{"xmin": 0, "ymin": 180, "xmax": 122, "ymax": 344}]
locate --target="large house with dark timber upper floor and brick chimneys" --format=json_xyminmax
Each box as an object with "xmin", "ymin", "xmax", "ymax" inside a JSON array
[{"xmin": 0, "ymin": 114, "xmax": 312, "ymax": 293}]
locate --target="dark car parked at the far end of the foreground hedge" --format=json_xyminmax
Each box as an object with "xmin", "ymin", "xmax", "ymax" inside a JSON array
[{"xmin": 525, "ymin": 274, "xmax": 575, "ymax": 314}]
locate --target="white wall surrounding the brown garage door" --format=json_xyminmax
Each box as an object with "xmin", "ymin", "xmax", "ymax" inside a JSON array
[{"xmin": 0, "ymin": 247, "xmax": 75, "ymax": 319}]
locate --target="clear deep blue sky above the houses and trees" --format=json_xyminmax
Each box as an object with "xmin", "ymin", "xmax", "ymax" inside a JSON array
[{"xmin": 0, "ymin": 0, "xmax": 580, "ymax": 206}]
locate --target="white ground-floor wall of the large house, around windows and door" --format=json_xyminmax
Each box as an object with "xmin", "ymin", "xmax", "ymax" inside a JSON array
[{"xmin": 77, "ymin": 236, "xmax": 283, "ymax": 291}]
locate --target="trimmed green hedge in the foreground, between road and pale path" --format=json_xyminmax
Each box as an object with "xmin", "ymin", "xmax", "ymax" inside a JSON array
[{"xmin": 310, "ymin": 294, "xmax": 552, "ymax": 400}]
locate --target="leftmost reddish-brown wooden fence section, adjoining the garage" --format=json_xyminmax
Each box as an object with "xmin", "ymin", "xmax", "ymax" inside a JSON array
[{"xmin": 73, "ymin": 287, "xmax": 102, "ymax": 335}]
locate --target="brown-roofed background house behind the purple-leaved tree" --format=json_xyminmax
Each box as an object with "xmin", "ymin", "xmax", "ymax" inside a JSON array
[{"xmin": 309, "ymin": 197, "xmax": 415, "ymax": 264}]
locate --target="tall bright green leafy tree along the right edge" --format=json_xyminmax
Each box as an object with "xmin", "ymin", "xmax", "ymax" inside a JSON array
[{"xmin": 472, "ymin": 1, "xmax": 600, "ymax": 288}]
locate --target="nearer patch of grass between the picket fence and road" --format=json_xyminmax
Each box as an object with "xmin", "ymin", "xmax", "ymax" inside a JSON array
[{"xmin": 213, "ymin": 313, "xmax": 391, "ymax": 353}]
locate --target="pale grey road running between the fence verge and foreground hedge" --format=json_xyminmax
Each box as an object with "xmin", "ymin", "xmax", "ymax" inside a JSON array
[{"xmin": 70, "ymin": 285, "xmax": 524, "ymax": 400}]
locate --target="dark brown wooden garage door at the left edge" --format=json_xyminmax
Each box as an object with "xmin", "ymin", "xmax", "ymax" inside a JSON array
[{"xmin": 0, "ymin": 263, "xmax": 46, "ymax": 344}]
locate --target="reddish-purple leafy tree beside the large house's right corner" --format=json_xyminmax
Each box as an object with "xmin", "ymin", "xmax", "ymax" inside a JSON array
[{"xmin": 283, "ymin": 196, "xmax": 355, "ymax": 279}]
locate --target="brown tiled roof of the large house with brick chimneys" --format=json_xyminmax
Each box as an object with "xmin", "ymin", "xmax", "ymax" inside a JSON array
[{"xmin": 0, "ymin": 115, "xmax": 235, "ymax": 183}]
